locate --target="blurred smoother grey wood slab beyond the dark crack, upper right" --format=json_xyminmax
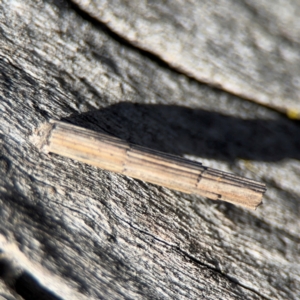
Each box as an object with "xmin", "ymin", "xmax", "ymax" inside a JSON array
[{"xmin": 72, "ymin": 0, "xmax": 300, "ymax": 118}]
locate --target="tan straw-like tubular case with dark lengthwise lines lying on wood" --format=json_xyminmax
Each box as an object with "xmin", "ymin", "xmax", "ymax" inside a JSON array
[{"xmin": 35, "ymin": 121, "xmax": 266, "ymax": 209}]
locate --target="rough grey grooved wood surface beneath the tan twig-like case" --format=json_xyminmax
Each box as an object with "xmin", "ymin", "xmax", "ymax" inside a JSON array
[{"xmin": 0, "ymin": 0, "xmax": 300, "ymax": 299}]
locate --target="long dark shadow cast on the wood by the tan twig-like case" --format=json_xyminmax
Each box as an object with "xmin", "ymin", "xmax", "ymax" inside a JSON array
[{"xmin": 64, "ymin": 102, "xmax": 300, "ymax": 162}]
